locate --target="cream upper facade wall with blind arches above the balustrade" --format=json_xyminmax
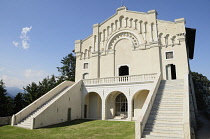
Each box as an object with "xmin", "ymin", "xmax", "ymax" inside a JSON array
[{"xmin": 75, "ymin": 7, "xmax": 189, "ymax": 81}]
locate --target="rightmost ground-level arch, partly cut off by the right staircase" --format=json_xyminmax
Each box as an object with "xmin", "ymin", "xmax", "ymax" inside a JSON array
[{"xmin": 132, "ymin": 90, "xmax": 149, "ymax": 120}]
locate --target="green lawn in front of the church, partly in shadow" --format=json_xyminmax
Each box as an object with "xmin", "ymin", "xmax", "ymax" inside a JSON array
[{"xmin": 0, "ymin": 120, "xmax": 134, "ymax": 139}]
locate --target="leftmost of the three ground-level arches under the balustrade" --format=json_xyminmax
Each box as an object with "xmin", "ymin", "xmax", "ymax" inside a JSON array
[{"xmin": 84, "ymin": 92, "xmax": 102, "ymax": 119}]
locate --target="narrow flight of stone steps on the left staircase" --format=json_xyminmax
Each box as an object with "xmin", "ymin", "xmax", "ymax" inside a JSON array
[{"xmin": 15, "ymin": 87, "xmax": 68, "ymax": 129}]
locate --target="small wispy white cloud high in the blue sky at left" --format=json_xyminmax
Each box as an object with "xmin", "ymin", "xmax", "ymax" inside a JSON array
[{"xmin": 13, "ymin": 26, "xmax": 32, "ymax": 49}]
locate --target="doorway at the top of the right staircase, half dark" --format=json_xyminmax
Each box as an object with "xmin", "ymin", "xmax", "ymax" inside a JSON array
[{"xmin": 166, "ymin": 64, "xmax": 176, "ymax": 80}]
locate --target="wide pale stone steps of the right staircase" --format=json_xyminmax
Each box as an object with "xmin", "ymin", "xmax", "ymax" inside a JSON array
[{"xmin": 142, "ymin": 80, "xmax": 184, "ymax": 139}]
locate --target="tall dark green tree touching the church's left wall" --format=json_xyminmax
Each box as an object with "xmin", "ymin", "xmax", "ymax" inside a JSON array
[{"xmin": 57, "ymin": 53, "xmax": 76, "ymax": 81}]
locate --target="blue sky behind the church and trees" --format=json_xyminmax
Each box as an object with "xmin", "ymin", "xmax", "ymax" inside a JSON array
[{"xmin": 0, "ymin": 0, "xmax": 210, "ymax": 88}]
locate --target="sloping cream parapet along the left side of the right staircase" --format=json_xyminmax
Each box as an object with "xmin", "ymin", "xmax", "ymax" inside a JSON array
[{"xmin": 135, "ymin": 73, "xmax": 162, "ymax": 139}]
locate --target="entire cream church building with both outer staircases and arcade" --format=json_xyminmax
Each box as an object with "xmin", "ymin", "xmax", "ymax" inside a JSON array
[{"xmin": 12, "ymin": 7, "xmax": 197, "ymax": 139}]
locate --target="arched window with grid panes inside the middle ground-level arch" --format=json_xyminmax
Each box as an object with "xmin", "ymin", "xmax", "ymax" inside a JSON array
[{"xmin": 115, "ymin": 93, "xmax": 128, "ymax": 116}]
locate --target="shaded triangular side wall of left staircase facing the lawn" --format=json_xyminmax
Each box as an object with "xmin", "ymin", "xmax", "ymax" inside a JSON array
[{"xmin": 34, "ymin": 81, "xmax": 81, "ymax": 128}]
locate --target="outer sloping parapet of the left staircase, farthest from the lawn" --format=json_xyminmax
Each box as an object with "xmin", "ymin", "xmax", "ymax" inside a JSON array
[{"xmin": 11, "ymin": 81, "xmax": 74, "ymax": 126}]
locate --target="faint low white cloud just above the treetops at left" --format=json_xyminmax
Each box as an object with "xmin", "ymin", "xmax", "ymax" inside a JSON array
[{"xmin": 24, "ymin": 69, "xmax": 46, "ymax": 78}]
